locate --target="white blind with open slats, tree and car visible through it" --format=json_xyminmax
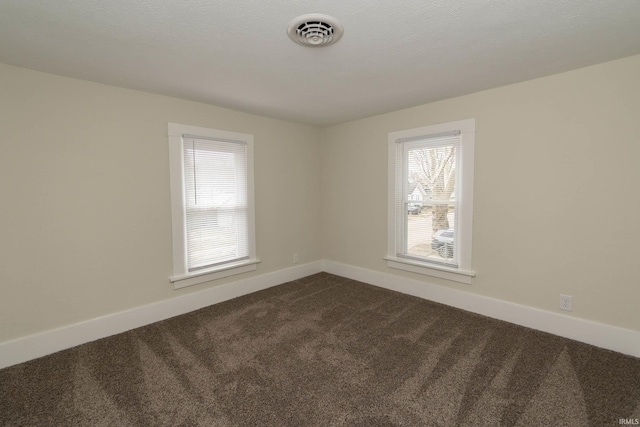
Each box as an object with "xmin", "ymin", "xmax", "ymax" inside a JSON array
[{"xmin": 395, "ymin": 131, "xmax": 461, "ymax": 268}]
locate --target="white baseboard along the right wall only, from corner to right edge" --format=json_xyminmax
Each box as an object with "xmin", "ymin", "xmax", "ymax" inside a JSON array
[{"xmin": 323, "ymin": 260, "xmax": 640, "ymax": 357}]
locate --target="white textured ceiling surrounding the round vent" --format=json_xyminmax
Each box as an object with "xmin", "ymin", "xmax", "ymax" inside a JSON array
[{"xmin": 0, "ymin": 0, "xmax": 640, "ymax": 125}]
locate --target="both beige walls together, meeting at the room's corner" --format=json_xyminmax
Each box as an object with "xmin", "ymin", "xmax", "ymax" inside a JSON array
[{"xmin": 0, "ymin": 56, "xmax": 640, "ymax": 348}]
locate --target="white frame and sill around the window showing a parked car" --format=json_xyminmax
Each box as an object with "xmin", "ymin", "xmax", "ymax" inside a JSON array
[{"xmin": 384, "ymin": 119, "xmax": 476, "ymax": 284}]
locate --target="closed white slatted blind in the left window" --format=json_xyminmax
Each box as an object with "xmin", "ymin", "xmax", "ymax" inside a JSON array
[{"xmin": 183, "ymin": 135, "xmax": 249, "ymax": 272}]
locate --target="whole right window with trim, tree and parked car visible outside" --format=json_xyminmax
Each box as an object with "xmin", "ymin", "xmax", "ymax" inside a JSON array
[{"xmin": 385, "ymin": 119, "xmax": 475, "ymax": 283}]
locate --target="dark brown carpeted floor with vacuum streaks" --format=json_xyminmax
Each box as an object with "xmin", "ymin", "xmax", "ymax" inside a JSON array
[{"xmin": 0, "ymin": 273, "xmax": 640, "ymax": 427}]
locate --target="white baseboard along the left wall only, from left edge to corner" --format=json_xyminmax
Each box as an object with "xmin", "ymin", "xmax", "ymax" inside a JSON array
[{"xmin": 0, "ymin": 261, "xmax": 323, "ymax": 369}]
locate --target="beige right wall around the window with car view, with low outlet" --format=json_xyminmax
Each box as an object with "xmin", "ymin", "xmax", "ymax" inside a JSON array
[{"xmin": 322, "ymin": 56, "xmax": 640, "ymax": 331}]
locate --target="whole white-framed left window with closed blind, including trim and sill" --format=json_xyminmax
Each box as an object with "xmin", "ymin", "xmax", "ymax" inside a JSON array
[{"xmin": 169, "ymin": 123, "xmax": 259, "ymax": 289}]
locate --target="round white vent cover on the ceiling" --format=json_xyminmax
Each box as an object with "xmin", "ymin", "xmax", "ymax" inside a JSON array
[{"xmin": 287, "ymin": 13, "xmax": 344, "ymax": 47}]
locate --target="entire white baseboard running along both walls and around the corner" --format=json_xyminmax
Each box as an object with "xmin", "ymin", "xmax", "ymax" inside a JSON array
[{"xmin": 0, "ymin": 260, "xmax": 640, "ymax": 369}]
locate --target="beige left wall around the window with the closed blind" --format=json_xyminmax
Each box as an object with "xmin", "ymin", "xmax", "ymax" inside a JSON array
[{"xmin": 0, "ymin": 65, "xmax": 321, "ymax": 342}]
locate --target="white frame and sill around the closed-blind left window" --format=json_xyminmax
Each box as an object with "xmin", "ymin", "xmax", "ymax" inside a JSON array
[{"xmin": 168, "ymin": 123, "xmax": 260, "ymax": 289}]
